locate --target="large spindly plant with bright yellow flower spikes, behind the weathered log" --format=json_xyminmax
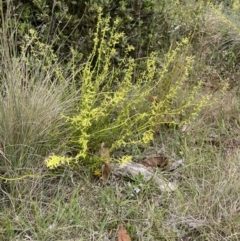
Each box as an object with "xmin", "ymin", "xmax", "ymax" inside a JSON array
[{"xmin": 46, "ymin": 7, "xmax": 214, "ymax": 169}]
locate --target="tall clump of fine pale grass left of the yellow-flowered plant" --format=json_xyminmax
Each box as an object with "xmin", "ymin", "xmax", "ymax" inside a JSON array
[{"xmin": 0, "ymin": 20, "xmax": 78, "ymax": 174}]
